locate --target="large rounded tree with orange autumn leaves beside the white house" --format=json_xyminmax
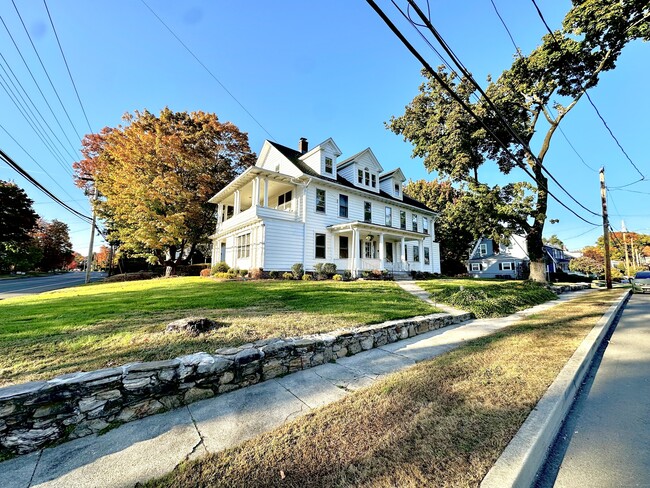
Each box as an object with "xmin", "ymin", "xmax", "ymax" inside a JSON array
[{"xmin": 74, "ymin": 108, "xmax": 255, "ymax": 269}]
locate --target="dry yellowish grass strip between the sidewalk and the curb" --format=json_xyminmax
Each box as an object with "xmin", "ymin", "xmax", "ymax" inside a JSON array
[{"xmin": 147, "ymin": 290, "xmax": 621, "ymax": 488}]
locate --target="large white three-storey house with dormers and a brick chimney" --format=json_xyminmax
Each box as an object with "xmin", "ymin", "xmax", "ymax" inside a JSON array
[{"xmin": 209, "ymin": 138, "xmax": 440, "ymax": 276}]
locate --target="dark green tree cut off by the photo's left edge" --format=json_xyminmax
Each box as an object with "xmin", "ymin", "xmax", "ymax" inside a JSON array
[{"xmin": 0, "ymin": 180, "xmax": 39, "ymax": 273}]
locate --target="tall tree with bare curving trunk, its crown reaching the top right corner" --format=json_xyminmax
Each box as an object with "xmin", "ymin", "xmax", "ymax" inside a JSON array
[{"xmin": 388, "ymin": 0, "xmax": 650, "ymax": 281}]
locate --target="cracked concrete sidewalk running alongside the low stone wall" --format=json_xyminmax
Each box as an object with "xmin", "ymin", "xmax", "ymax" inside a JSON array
[{"xmin": 0, "ymin": 291, "xmax": 590, "ymax": 488}]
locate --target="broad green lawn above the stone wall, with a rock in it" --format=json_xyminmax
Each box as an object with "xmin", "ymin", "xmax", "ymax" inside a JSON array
[{"xmin": 0, "ymin": 277, "xmax": 436, "ymax": 386}]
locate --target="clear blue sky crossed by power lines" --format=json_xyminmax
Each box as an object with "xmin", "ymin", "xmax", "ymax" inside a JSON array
[{"xmin": 0, "ymin": 0, "xmax": 650, "ymax": 255}]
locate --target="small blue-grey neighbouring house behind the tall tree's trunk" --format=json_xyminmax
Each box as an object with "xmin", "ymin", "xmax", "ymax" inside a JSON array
[{"xmin": 467, "ymin": 235, "xmax": 530, "ymax": 278}]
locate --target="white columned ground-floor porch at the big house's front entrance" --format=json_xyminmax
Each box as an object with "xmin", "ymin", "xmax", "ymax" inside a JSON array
[{"xmin": 328, "ymin": 222, "xmax": 437, "ymax": 277}]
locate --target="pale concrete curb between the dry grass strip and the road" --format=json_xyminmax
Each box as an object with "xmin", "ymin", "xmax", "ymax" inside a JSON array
[{"xmin": 480, "ymin": 291, "xmax": 631, "ymax": 488}]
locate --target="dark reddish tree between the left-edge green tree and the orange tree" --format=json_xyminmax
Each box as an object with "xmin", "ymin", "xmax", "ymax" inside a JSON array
[{"xmin": 34, "ymin": 219, "xmax": 74, "ymax": 271}]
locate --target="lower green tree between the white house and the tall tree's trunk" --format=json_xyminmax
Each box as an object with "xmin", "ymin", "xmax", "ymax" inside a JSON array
[{"xmin": 404, "ymin": 180, "xmax": 532, "ymax": 275}]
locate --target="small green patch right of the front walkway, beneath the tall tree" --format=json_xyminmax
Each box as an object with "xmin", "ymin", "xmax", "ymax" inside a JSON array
[{"xmin": 418, "ymin": 279, "xmax": 557, "ymax": 318}]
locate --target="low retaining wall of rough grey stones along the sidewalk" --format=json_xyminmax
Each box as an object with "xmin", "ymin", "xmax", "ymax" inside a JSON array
[{"xmin": 0, "ymin": 314, "xmax": 471, "ymax": 454}]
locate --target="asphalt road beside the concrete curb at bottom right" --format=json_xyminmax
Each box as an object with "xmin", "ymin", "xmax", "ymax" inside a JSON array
[{"xmin": 536, "ymin": 295, "xmax": 650, "ymax": 488}]
